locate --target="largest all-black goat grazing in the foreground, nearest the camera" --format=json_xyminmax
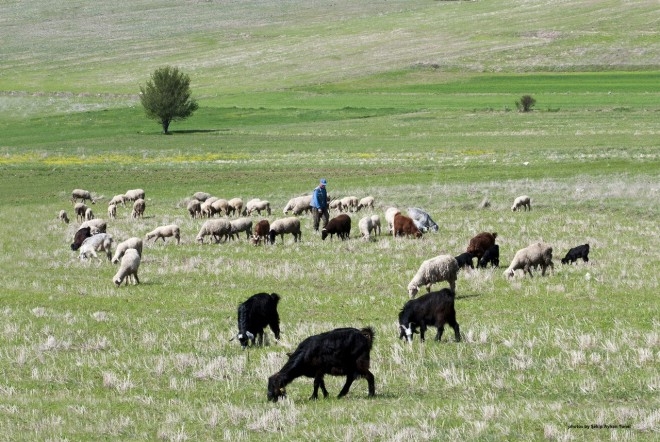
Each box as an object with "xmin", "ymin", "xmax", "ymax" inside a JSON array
[{"xmin": 268, "ymin": 327, "xmax": 376, "ymax": 402}]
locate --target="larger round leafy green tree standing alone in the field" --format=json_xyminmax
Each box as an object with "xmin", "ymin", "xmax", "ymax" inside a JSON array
[{"xmin": 140, "ymin": 66, "xmax": 199, "ymax": 134}]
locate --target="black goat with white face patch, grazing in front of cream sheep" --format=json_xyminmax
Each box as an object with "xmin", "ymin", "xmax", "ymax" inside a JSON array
[{"xmin": 399, "ymin": 288, "xmax": 461, "ymax": 342}]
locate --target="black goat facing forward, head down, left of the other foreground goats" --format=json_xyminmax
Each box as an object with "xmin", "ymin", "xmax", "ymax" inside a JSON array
[{"xmin": 236, "ymin": 293, "xmax": 280, "ymax": 349}]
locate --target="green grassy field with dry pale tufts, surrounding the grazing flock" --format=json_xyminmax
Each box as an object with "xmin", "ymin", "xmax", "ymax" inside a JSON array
[{"xmin": 0, "ymin": 0, "xmax": 660, "ymax": 441}]
